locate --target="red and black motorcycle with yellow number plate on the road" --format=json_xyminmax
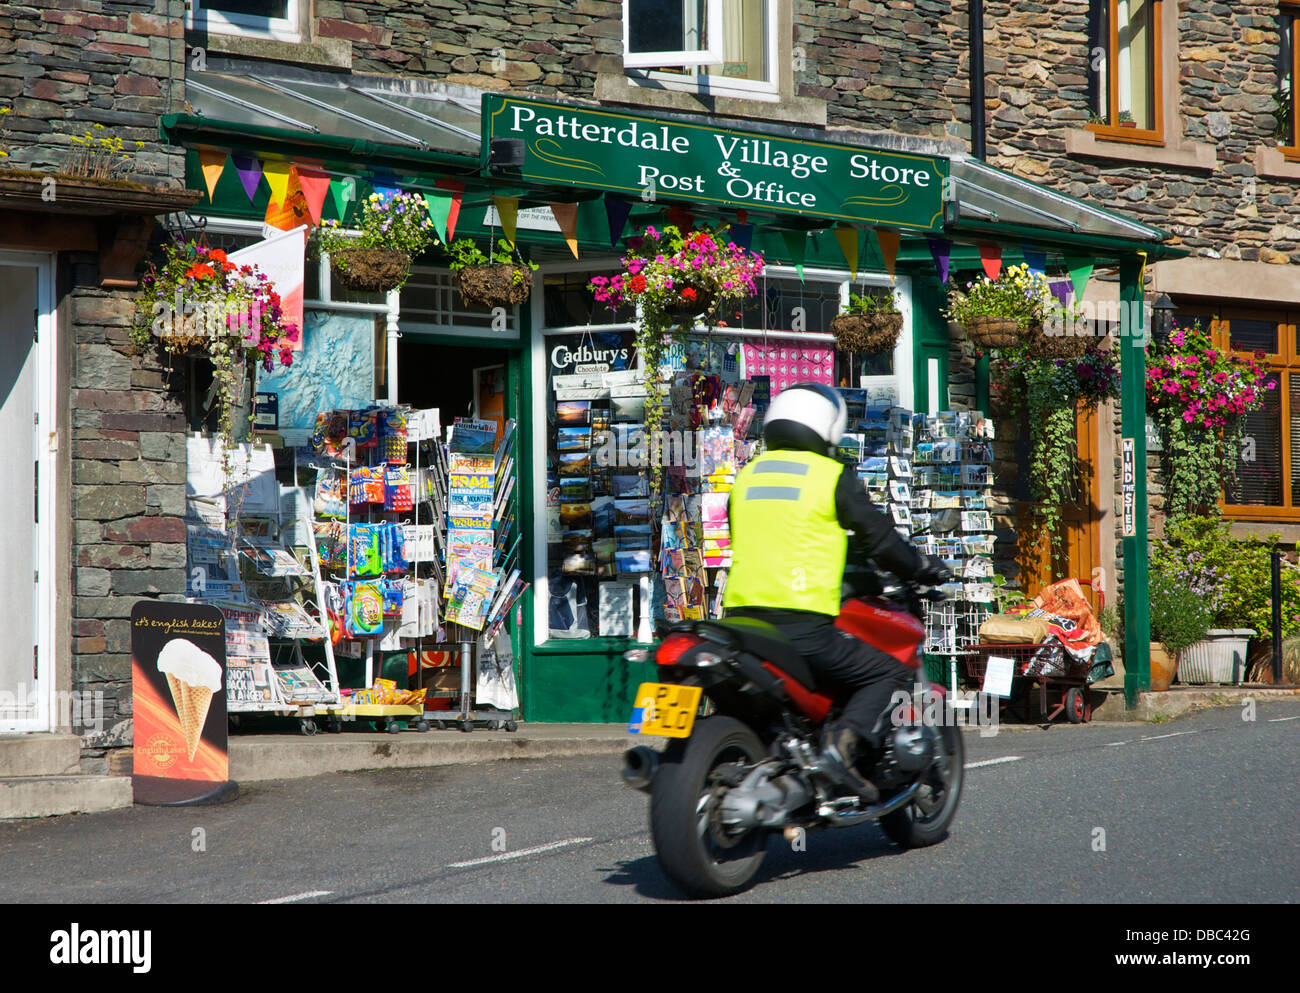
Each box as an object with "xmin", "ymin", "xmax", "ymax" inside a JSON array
[{"xmin": 623, "ymin": 582, "xmax": 965, "ymax": 897}]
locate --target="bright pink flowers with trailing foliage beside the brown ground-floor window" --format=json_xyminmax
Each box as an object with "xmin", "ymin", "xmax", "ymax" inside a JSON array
[{"xmin": 1147, "ymin": 322, "xmax": 1278, "ymax": 522}]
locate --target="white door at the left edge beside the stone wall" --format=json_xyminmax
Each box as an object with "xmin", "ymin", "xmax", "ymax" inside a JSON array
[{"xmin": 0, "ymin": 252, "xmax": 56, "ymax": 733}]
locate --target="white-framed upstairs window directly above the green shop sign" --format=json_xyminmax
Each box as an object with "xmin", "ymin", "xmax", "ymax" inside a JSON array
[{"xmin": 623, "ymin": 0, "xmax": 779, "ymax": 96}]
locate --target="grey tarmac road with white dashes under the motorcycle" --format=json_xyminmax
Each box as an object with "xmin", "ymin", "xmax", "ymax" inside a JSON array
[{"xmin": 0, "ymin": 701, "xmax": 1300, "ymax": 905}]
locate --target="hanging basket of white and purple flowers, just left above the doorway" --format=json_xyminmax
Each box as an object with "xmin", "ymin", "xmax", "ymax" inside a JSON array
[{"xmin": 311, "ymin": 192, "xmax": 437, "ymax": 292}]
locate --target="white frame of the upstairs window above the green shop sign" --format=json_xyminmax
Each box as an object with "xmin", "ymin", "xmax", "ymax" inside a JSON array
[{"xmin": 623, "ymin": 0, "xmax": 784, "ymax": 101}]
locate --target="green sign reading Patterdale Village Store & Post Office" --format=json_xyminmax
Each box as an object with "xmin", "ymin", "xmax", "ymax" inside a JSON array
[{"xmin": 482, "ymin": 94, "xmax": 948, "ymax": 231}]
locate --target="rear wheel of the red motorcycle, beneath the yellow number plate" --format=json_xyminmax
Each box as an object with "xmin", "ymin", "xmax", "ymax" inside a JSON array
[{"xmin": 650, "ymin": 716, "xmax": 767, "ymax": 897}]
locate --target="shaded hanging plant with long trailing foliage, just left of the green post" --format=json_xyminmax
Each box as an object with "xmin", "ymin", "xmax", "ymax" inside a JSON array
[{"xmin": 993, "ymin": 339, "xmax": 1119, "ymax": 558}]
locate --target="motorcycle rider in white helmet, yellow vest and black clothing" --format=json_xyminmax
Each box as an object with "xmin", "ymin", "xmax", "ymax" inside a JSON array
[{"xmin": 723, "ymin": 383, "xmax": 950, "ymax": 803}]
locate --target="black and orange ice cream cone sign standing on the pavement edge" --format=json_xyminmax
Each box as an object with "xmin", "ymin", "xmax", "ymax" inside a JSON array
[{"xmin": 131, "ymin": 600, "xmax": 233, "ymax": 805}]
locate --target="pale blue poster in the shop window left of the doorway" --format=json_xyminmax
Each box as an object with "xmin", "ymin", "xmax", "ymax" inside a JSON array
[{"xmin": 257, "ymin": 311, "xmax": 374, "ymax": 432}]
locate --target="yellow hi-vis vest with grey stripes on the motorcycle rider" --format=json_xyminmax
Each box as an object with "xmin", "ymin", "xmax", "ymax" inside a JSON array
[{"xmin": 723, "ymin": 450, "xmax": 848, "ymax": 616}]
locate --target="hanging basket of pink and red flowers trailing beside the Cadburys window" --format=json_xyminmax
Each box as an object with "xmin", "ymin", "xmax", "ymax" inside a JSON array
[{"xmin": 588, "ymin": 225, "xmax": 764, "ymax": 493}]
